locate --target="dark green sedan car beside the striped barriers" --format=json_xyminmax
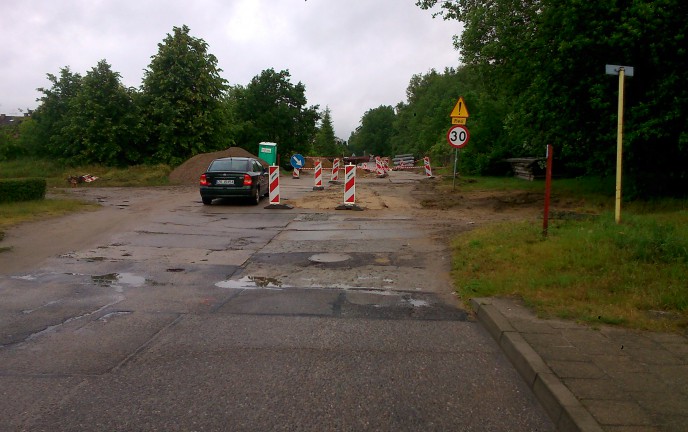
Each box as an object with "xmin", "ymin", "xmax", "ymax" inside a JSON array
[{"xmin": 200, "ymin": 157, "xmax": 269, "ymax": 205}]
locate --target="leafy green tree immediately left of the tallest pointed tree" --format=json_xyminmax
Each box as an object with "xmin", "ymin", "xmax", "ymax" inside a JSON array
[{"xmin": 63, "ymin": 60, "xmax": 141, "ymax": 166}]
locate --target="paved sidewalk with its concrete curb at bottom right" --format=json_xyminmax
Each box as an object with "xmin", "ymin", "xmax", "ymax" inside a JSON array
[{"xmin": 472, "ymin": 298, "xmax": 688, "ymax": 432}]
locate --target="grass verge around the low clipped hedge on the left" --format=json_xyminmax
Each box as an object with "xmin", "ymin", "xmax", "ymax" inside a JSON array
[{"xmin": 0, "ymin": 160, "xmax": 170, "ymax": 246}]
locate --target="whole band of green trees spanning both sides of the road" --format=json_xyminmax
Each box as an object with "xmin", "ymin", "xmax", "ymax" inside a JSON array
[{"xmin": 5, "ymin": 0, "xmax": 688, "ymax": 197}]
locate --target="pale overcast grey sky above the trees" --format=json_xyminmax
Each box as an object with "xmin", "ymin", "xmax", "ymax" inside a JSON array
[{"xmin": 0, "ymin": 0, "xmax": 461, "ymax": 140}]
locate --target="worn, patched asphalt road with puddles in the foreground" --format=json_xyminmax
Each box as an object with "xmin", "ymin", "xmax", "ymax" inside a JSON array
[{"xmin": 0, "ymin": 175, "xmax": 554, "ymax": 431}]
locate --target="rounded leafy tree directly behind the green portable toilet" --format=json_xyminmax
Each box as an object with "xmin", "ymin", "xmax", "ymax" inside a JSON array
[{"xmin": 234, "ymin": 69, "xmax": 320, "ymax": 162}]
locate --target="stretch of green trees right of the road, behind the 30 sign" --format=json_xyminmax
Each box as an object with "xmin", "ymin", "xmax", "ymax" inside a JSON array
[{"xmin": 349, "ymin": 0, "xmax": 688, "ymax": 197}]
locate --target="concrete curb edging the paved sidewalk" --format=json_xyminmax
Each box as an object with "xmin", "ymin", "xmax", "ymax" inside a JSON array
[{"xmin": 471, "ymin": 298, "xmax": 603, "ymax": 432}]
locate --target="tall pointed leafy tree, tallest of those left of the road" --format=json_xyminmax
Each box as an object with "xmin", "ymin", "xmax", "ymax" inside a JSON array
[{"xmin": 142, "ymin": 26, "xmax": 229, "ymax": 165}]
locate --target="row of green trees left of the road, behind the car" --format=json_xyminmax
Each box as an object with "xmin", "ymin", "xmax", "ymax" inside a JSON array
[{"xmin": 0, "ymin": 26, "xmax": 341, "ymax": 166}]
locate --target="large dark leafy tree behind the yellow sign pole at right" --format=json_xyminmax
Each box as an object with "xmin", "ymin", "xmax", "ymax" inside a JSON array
[{"xmin": 417, "ymin": 0, "xmax": 688, "ymax": 196}]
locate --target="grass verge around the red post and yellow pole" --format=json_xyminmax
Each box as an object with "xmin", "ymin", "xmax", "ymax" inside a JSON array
[{"xmin": 444, "ymin": 174, "xmax": 688, "ymax": 332}]
